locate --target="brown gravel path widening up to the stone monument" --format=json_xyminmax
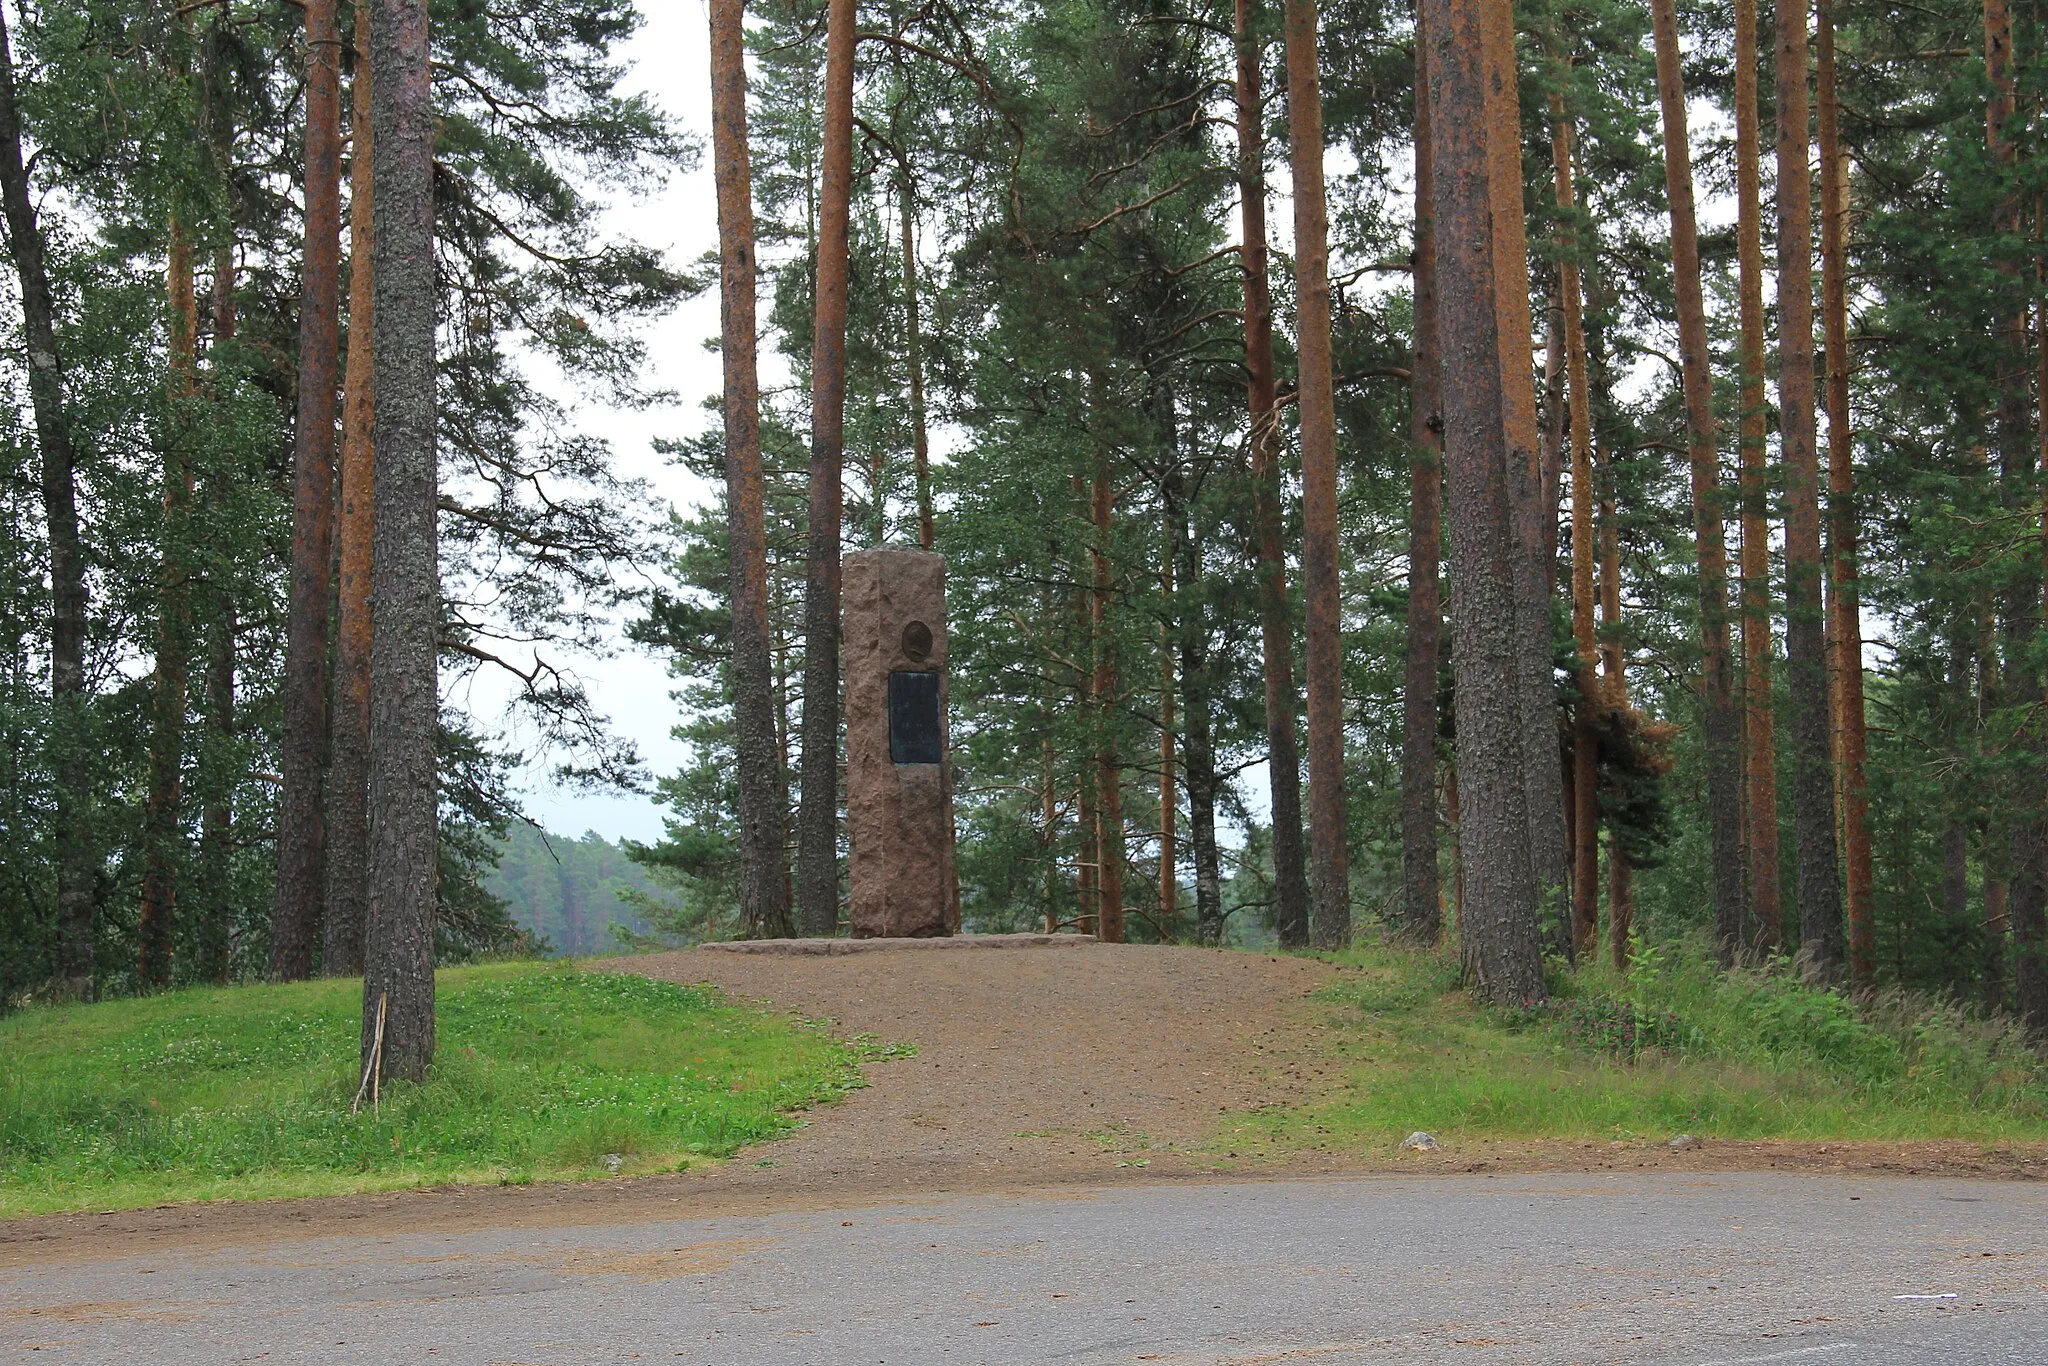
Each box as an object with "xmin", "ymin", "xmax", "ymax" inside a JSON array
[{"xmin": 631, "ymin": 944, "xmax": 1331, "ymax": 1192}]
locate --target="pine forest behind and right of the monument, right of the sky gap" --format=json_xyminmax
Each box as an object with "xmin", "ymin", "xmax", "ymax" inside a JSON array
[{"xmin": 633, "ymin": 0, "xmax": 2048, "ymax": 1028}]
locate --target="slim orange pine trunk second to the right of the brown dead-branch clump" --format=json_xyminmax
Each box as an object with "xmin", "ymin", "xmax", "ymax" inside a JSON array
[{"xmin": 1735, "ymin": 0, "xmax": 1784, "ymax": 954}]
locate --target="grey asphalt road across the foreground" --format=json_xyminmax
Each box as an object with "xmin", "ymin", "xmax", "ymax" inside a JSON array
[{"xmin": 0, "ymin": 1173, "xmax": 2048, "ymax": 1366}]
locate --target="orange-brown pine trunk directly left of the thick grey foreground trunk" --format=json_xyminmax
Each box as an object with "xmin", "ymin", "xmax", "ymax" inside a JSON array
[{"xmin": 319, "ymin": 2, "xmax": 377, "ymax": 977}]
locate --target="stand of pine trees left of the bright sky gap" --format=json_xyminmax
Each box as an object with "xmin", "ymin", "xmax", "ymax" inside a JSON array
[{"xmin": 0, "ymin": 0, "xmax": 707, "ymax": 1077}]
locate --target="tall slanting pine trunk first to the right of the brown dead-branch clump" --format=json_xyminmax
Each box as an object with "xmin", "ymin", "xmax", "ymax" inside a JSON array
[{"xmin": 1651, "ymin": 0, "xmax": 1747, "ymax": 967}]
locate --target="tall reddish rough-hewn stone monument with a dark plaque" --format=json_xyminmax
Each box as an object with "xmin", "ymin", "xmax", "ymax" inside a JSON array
[{"xmin": 840, "ymin": 549, "xmax": 961, "ymax": 940}]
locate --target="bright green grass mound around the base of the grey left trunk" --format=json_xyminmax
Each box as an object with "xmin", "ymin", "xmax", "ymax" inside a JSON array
[{"xmin": 0, "ymin": 963, "xmax": 877, "ymax": 1216}]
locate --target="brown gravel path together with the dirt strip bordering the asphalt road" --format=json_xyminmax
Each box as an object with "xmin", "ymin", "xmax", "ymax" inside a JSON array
[{"xmin": 0, "ymin": 946, "xmax": 2048, "ymax": 1268}]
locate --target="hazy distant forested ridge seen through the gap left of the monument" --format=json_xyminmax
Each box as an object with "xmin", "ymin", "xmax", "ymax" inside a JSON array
[{"xmin": 483, "ymin": 821, "xmax": 655, "ymax": 956}]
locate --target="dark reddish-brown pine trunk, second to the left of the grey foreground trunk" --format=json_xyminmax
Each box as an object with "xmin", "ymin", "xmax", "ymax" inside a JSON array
[{"xmin": 270, "ymin": 0, "xmax": 342, "ymax": 981}]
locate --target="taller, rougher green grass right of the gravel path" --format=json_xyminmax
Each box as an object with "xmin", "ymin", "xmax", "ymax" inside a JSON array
[{"xmin": 1223, "ymin": 944, "xmax": 2048, "ymax": 1155}]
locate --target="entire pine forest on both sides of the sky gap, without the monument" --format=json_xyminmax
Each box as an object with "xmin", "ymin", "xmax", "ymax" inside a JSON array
[{"xmin": 0, "ymin": 0, "xmax": 2048, "ymax": 1075}]
